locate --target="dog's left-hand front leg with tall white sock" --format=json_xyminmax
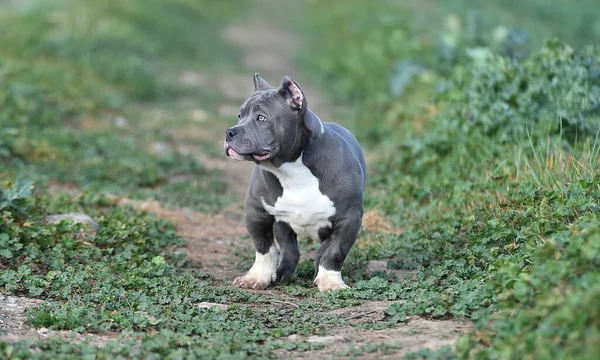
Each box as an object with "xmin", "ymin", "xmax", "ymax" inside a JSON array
[{"xmin": 233, "ymin": 215, "xmax": 279, "ymax": 290}]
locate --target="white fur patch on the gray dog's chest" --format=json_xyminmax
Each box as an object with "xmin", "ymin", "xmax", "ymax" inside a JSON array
[{"xmin": 261, "ymin": 155, "xmax": 335, "ymax": 240}]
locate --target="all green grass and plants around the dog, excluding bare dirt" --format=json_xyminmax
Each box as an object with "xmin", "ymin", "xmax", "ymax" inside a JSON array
[{"xmin": 0, "ymin": 0, "xmax": 600, "ymax": 359}]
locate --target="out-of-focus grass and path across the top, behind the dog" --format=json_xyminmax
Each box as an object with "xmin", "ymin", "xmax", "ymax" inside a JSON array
[{"xmin": 0, "ymin": 0, "xmax": 600, "ymax": 204}]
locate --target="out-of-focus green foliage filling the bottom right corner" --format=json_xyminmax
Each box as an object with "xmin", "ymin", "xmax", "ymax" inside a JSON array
[{"xmin": 459, "ymin": 217, "xmax": 600, "ymax": 358}]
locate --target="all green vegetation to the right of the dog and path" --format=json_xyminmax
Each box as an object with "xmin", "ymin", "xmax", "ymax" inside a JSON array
[{"xmin": 286, "ymin": 1, "xmax": 600, "ymax": 359}]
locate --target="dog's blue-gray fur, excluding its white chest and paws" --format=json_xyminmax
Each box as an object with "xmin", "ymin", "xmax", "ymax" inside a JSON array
[{"xmin": 224, "ymin": 74, "xmax": 366, "ymax": 290}]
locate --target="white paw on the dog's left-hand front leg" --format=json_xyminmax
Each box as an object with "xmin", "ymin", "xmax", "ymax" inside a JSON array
[{"xmin": 233, "ymin": 246, "xmax": 279, "ymax": 290}]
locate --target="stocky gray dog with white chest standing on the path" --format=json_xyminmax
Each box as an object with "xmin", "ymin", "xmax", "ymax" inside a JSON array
[{"xmin": 224, "ymin": 73, "xmax": 367, "ymax": 291}]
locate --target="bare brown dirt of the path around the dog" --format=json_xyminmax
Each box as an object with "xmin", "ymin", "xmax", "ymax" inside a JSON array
[{"xmin": 167, "ymin": 9, "xmax": 469, "ymax": 359}]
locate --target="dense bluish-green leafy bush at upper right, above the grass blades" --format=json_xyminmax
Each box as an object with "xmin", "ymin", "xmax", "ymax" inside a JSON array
[{"xmin": 438, "ymin": 41, "xmax": 600, "ymax": 143}]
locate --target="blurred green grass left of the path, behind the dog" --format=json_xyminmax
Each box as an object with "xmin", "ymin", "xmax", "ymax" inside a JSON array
[{"xmin": 0, "ymin": 1, "xmax": 247, "ymax": 212}]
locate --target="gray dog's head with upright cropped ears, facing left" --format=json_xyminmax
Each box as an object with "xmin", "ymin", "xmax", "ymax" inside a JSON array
[{"xmin": 224, "ymin": 74, "xmax": 308, "ymax": 163}]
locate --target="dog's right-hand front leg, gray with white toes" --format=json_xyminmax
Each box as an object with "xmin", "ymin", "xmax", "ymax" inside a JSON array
[{"xmin": 314, "ymin": 214, "xmax": 362, "ymax": 291}]
